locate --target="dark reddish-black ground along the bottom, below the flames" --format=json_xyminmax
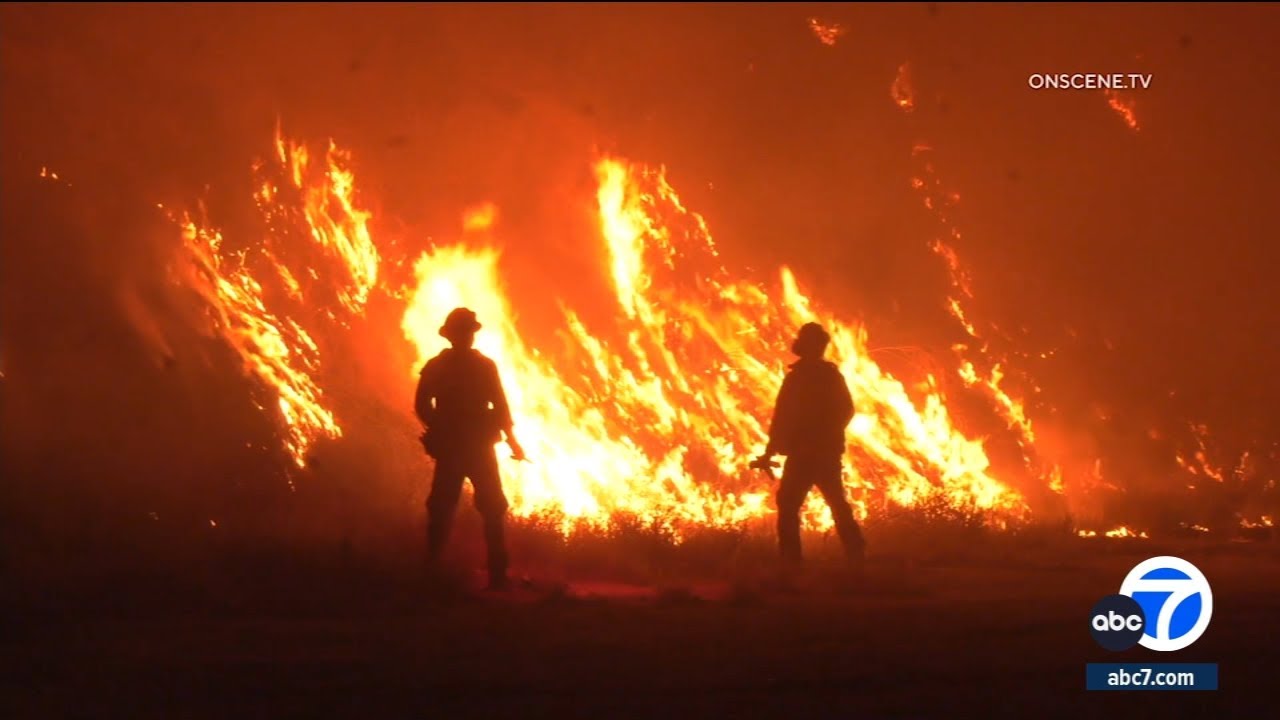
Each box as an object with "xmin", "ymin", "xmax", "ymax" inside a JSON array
[{"xmin": 0, "ymin": 530, "xmax": 1280, "ymax": 719}]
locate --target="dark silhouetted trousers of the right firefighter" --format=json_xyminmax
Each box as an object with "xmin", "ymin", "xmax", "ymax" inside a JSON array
[{"xmin": 777, "ymin": 455, "xmax": 865, "ymax": 564}]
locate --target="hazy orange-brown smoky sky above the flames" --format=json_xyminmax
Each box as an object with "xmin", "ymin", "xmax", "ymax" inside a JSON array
[{"xmin": 0, "ymin": 4, "xmax": 1280, "ymax": 453}]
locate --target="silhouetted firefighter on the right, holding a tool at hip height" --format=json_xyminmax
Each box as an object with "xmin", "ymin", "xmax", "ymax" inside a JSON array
[{"xmin": 751, "ymin": 323, "xmax": 865, "ymax": 569}]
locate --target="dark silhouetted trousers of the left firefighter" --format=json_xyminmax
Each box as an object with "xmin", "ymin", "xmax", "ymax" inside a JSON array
[{"xmin": 426, "ymin": 446, "xmax": 507, "ymax": 578}]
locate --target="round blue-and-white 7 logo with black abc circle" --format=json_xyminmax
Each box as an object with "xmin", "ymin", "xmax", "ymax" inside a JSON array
[{"xmin": 1089, "ymin": 556, "xmax": 1213, "ymax": 652}]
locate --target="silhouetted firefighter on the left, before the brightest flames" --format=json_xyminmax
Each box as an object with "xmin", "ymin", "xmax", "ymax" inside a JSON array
[{"xmin": 415, "ymin": 307, "xmax": 525, "ymax": 589}]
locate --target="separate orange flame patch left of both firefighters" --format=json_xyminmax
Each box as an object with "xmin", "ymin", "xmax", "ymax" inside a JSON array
[{"xmin": 178, "ymin": 129, "xmax": 379, "ymax": 468}]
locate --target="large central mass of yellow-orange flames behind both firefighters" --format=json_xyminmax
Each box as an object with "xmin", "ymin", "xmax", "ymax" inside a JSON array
[{"xmin": 402, "ymin": 159, "xmax": 1025, "ymax": 528}]
